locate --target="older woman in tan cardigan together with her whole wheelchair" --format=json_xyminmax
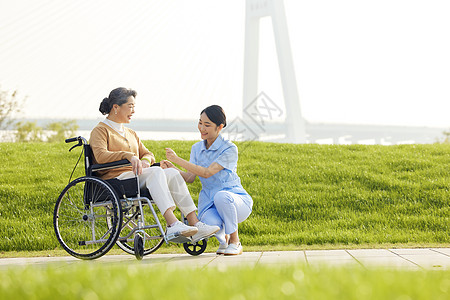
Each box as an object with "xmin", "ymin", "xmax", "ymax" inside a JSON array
[{"xmin": 54, "ymin": 88, "xmax": 219, "ymax": 259}]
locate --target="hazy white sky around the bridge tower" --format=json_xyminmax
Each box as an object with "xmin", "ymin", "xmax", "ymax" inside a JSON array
[{"xmin": 0, "ymin": 0, "xmax": 450, "ymax": 127}]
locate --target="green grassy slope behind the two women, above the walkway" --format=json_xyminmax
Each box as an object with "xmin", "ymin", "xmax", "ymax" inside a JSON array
[{"xmin": 0, "ymin": 141, "xmax": 450, "ymax": 251}]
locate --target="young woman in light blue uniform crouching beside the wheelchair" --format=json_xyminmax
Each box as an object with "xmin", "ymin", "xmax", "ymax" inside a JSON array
[{"xmin": 161, "ymin": 105, "xmax": 253, "ymax": 255}]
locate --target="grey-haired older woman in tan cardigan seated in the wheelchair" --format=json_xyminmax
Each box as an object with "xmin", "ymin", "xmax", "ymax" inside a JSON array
[{"xmin": 90, "ymin": 88, "xmax": 219, "ymax": 242}]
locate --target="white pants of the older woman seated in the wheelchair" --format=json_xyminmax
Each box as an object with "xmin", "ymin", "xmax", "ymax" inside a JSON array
[{"xmin": 117, "ymin": 167, "xmax": 197, "ymax": 216}]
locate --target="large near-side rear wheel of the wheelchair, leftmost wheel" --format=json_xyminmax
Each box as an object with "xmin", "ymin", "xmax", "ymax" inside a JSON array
[{"xmin": 53, "ymin": 177, "xmax": 122, "ymax": 259}]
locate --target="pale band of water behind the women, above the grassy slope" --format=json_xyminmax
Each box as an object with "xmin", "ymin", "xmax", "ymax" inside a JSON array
[{"xmin": 0, "ymin": 120, "xmax": 448, "ymax": 145}]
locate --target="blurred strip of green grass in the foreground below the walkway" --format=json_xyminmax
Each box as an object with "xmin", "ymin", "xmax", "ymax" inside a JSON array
[{"xmin": 0, "ymin": 261, "xmax": 450, "ymax": 300}]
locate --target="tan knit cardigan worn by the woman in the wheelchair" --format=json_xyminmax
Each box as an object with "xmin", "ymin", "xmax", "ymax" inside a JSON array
[{"xmin": 89, "ymin": 122, "xmax": 155, "ymax": 179}]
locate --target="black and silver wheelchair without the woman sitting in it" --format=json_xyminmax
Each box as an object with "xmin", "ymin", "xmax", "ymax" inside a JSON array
[{"xmin": 53, "ymin": 136, "xmax": 207, "ymax": 260}]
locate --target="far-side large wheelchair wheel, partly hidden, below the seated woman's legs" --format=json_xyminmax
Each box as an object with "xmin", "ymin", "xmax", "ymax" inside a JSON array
[{"xmin": 116, "ymin": 203, "xmax": 165, "ymax": 255}]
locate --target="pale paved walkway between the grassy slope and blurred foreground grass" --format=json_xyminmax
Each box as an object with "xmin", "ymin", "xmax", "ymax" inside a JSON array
[{"xmin": 0, "ymin": 248, "xmax": 450, "ymax": 270}]
